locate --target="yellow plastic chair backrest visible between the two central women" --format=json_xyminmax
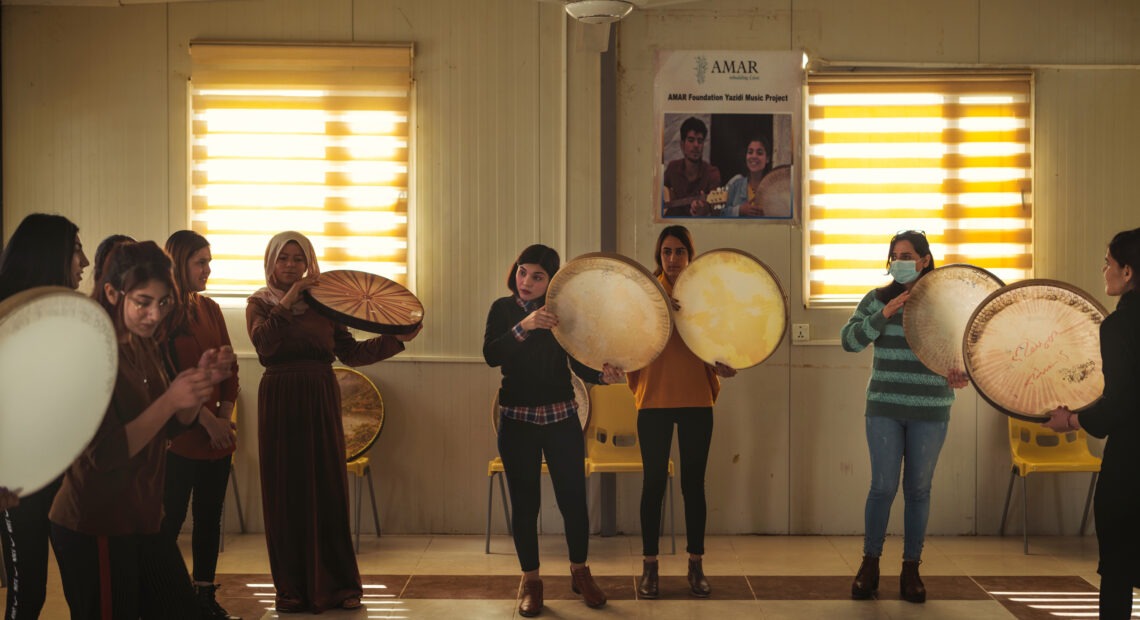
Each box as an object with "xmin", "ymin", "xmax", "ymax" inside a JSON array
[{"xmin": 586, "ymin": 384, "xmax": 641, "ymax": 463}]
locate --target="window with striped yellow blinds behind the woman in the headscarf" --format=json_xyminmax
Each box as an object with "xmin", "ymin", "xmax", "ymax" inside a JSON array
[{"xmin": 190, "ymin": 43, "xmax": 413, "ymax": 296}]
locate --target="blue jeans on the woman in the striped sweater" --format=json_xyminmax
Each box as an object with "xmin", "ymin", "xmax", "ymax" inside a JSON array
[{"xmin": 863, "ymin": 416, "xmax": 950, "ymax": 561}]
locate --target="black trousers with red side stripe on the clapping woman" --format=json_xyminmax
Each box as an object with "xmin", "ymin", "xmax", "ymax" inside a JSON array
[{"xmin": 51, "ymin": 523, "xmax": 202, "ymax": 620}]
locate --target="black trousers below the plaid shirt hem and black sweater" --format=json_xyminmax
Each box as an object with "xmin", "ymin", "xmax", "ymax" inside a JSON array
[{"xmin": 498, "ymin": 416, "xmax": 589, "ymax": 572}]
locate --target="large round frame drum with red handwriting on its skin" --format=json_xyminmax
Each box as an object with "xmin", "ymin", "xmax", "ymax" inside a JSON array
[{"xmin": 962, "ymin": 279, "xmax": 1107, "ymax": 422}]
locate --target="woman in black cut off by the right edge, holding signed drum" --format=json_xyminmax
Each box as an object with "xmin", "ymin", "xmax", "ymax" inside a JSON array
[{"xmin": 1047, "ymin": 228, "xmax": 1140, "ymax": 620}]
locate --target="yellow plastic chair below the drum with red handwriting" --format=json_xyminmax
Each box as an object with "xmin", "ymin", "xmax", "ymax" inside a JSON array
[{"xmin": 1000, "ymin": 417, "xmax": 1100, "ymax": 555}]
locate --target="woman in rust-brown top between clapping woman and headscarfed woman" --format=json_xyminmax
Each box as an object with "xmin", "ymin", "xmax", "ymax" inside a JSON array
[{"xmin": 162, "ymin": 230, "xmax": 237, "ymax": 620}]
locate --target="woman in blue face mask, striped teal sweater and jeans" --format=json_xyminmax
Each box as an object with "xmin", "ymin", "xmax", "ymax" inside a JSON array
[{"xmin": 840, "ymin": 230, "xmax": 967, "ymax": 603}]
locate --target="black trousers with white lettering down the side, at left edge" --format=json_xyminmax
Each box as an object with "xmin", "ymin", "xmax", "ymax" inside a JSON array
[{"xmin": 0, "ymin": 478, "xmax": 63, "ymax": 620}]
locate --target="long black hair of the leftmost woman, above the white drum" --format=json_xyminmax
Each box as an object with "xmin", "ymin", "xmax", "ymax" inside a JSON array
[{"xmin": 0, "ymin": 213, "xmax": 79, "ymax": 300}]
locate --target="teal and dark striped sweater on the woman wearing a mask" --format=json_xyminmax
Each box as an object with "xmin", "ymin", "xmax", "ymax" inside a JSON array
[{"xmin": 839, "ymin": 291, "xmax": 954, "ymax": 422}]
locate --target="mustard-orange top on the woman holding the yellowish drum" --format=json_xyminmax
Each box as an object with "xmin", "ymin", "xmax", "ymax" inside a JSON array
[{"xmin": 626, "ymin": 274, "xmax": 720, "ymax": 409}]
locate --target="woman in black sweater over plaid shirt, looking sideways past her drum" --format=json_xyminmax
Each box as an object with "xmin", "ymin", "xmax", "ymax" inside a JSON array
[{"xmin": 483, "ymin": 244, "xmax": 622, "ymax": 618}]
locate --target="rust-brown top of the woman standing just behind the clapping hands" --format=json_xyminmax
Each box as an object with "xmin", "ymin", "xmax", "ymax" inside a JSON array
[{"xmin": 170, "ymin": 293, "xmax": 237, "ymax": 459}]
